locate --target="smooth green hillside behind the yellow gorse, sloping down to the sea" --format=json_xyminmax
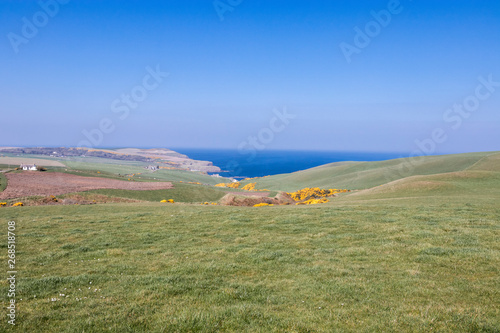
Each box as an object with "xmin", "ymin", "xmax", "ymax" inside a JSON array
[{"xmin": 248, "ymin": 152, "xmax": 500, "ymax": 191}]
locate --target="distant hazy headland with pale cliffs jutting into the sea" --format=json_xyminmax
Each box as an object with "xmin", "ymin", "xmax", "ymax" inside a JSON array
[{"xmin": 0, "ymin": 147, "xmax": 221, "ymax": 172}]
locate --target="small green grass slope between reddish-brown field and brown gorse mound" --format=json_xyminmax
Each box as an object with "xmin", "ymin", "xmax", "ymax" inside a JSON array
[{"xmin": 87, "ymin": 183, "xmax": 228, "ymax": 203}]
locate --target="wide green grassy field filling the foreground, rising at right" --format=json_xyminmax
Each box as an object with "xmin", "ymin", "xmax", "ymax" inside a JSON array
[{"xmin": 0, "ymin": 154, "xmax": 500, "ymax": 332}]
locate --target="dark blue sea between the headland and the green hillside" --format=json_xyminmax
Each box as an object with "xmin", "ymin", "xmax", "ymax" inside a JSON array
[{"xmin": 171, "ymin": 148, "xmax": 405, "ymax": 178}]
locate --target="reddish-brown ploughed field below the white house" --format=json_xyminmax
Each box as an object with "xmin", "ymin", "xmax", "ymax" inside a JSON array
[{"xmin": 0, "ymin": 171, "xmax": 173, "ymax": 199}]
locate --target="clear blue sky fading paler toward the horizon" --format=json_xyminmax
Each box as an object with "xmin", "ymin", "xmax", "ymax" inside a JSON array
[{"xmin": 0, "ymin": 0, "xmax": 500, "ymax": 153}]
